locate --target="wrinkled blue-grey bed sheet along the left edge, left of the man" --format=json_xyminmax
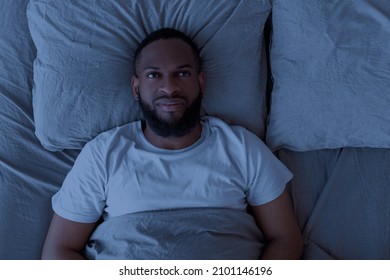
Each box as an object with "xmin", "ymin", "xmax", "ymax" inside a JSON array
[{"xmin": 0, "ymin": 0, "xmax": 77, "ymax": 259}]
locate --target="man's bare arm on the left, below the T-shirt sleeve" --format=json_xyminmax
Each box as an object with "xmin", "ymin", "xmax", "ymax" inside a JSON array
[{"xmin": 42, "ymin": 214, "xmax": 96, "ymax": 259}]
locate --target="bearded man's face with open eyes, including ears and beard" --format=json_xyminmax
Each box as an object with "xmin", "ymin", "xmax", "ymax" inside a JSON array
[{"xmin": 132, "ymin": 39, "xmax": 204, "ymax": 136}]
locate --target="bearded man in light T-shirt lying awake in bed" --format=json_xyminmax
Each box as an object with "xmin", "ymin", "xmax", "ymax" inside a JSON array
[{"xmin": 42, "ymin": 29, "xmax": 302, "ymax": 259}]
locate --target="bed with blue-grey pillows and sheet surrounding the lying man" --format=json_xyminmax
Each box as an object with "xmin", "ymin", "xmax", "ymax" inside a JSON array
[{"xmin": 0, "ymin": 0, "xmax": 390, "ymax": 259}]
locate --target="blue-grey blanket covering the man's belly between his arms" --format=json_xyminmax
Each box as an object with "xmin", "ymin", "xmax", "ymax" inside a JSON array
[{"xmin": 85, "ymin": 208, "xmax": 264, "ymax": 260}]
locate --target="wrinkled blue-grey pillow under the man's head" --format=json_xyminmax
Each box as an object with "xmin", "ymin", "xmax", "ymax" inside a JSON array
[{"xmin": 27, "ymin": 0, "xmax": 271, "ymax": 151}]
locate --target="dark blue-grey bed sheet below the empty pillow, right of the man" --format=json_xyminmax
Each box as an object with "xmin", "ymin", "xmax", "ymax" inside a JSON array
[{"xmin": 279, "ymin": 148, "xmax": 390, "ymax": 260}]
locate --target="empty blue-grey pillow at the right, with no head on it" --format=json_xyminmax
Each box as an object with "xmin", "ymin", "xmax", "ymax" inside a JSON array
[{"xmin": 266, "ymin": 0, "xmax": 390, "ymax": 151}]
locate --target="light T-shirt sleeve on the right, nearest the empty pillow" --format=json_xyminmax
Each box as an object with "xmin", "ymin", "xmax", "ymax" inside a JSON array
[{"xmin": 246, "ymin": 131, "xmax": 293, "ymax": 206}]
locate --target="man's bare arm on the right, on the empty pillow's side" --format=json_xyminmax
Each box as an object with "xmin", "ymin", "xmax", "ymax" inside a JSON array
[{"xmin": 252, "ymin": 190, "xmax": 303, "ymax": 259}]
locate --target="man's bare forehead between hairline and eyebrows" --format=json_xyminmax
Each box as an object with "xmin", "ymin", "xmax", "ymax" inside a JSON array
[{"xmin": 139, "ymin": 39, "xmax": 195, "ymax": 67}]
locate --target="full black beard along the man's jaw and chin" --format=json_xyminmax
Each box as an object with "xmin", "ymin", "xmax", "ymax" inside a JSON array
[{"xmin": 139, "ymin": 93, "xmax": 202, "ymax": 138}]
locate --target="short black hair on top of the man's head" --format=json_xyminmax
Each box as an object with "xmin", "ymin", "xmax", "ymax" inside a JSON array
[{"xmin": 134, "ymin": 28, "xmax": 202, "ymax": 74}]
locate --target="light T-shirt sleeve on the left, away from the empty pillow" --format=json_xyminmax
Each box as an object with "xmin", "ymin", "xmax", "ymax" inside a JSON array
[{"xmin": 52, "ymin": 142, "xmax": 106, "ymax": 223}]
